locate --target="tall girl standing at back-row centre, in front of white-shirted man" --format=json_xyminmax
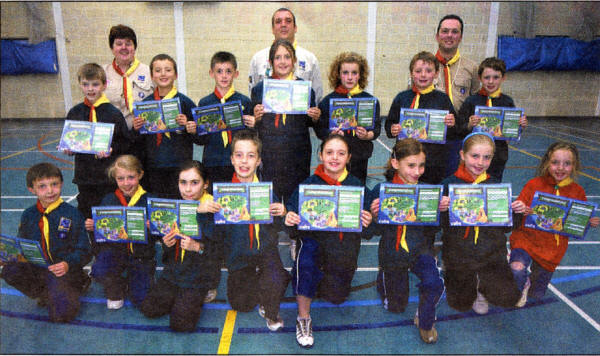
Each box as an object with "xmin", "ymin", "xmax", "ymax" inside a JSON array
[{"xmin": 252, "ymin": 40, "xmax": 321, "ymax": 202}]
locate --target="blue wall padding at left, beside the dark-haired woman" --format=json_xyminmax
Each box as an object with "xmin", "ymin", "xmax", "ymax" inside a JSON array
[{"xmin": 1, "ymin": 40, "xmax": 58, "ymax": 75}]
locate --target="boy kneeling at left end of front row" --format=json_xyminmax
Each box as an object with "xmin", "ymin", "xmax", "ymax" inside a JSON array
[{"xmin": 1, "ymin": 163, "xmax": 92, "ymax": 323}]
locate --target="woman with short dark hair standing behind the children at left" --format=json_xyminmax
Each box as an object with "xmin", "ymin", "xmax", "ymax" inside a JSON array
[{"xmin": 104, "ymin": 25, "xmax": 154, "ymax": 129}]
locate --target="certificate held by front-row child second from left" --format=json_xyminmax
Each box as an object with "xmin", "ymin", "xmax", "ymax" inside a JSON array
[{"xmin": 92, "ymin": 206, "xmax": 148, "ymax": 244}]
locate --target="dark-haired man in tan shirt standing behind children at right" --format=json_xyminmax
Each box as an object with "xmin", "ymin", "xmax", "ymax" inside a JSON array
[{"xmin": 435, "ymin": 15, "xmax": 479, "ymax": 175}]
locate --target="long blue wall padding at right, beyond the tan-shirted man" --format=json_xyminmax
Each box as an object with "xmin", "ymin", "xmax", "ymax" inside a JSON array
[{"xmin": 498, "ymin": 36, "xmax": 600, "ymax": 72}]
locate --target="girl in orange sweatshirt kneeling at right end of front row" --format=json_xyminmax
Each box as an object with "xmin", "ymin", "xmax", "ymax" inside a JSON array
[{"xmin": 510, "ymin": 142, "xmax": 600, "ymax": 306}]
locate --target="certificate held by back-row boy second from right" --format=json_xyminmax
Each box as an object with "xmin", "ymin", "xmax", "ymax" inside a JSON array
[{"xmin": 398, "ymin": 108, "xmax": 448, "ymax": 144}]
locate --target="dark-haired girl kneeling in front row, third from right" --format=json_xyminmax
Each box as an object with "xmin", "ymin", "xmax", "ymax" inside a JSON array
[{"xmin": 368, "ymin": 138, "xmax": 449, "ymax": 344}]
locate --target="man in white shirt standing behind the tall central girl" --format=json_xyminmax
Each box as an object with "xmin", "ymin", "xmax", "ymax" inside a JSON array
[{"xmin": 248, "ymin": 8, "xmax": 323, "ymax": 103}]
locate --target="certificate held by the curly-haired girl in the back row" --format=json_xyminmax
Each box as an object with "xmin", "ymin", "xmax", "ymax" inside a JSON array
[{"xmin": 329, "ymin": 98, "xmax": 377, "ymax": 131}]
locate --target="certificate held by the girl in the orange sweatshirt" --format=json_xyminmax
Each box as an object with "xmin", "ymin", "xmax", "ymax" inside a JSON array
[{"xmin": 525, "ymin": 192, "xmax": 598, "ymax": 239}]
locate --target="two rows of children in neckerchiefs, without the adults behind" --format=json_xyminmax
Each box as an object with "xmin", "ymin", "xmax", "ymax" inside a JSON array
[{"xmin": 2, "ymin": 28, "xmax": 600, "ymax": 348}]
